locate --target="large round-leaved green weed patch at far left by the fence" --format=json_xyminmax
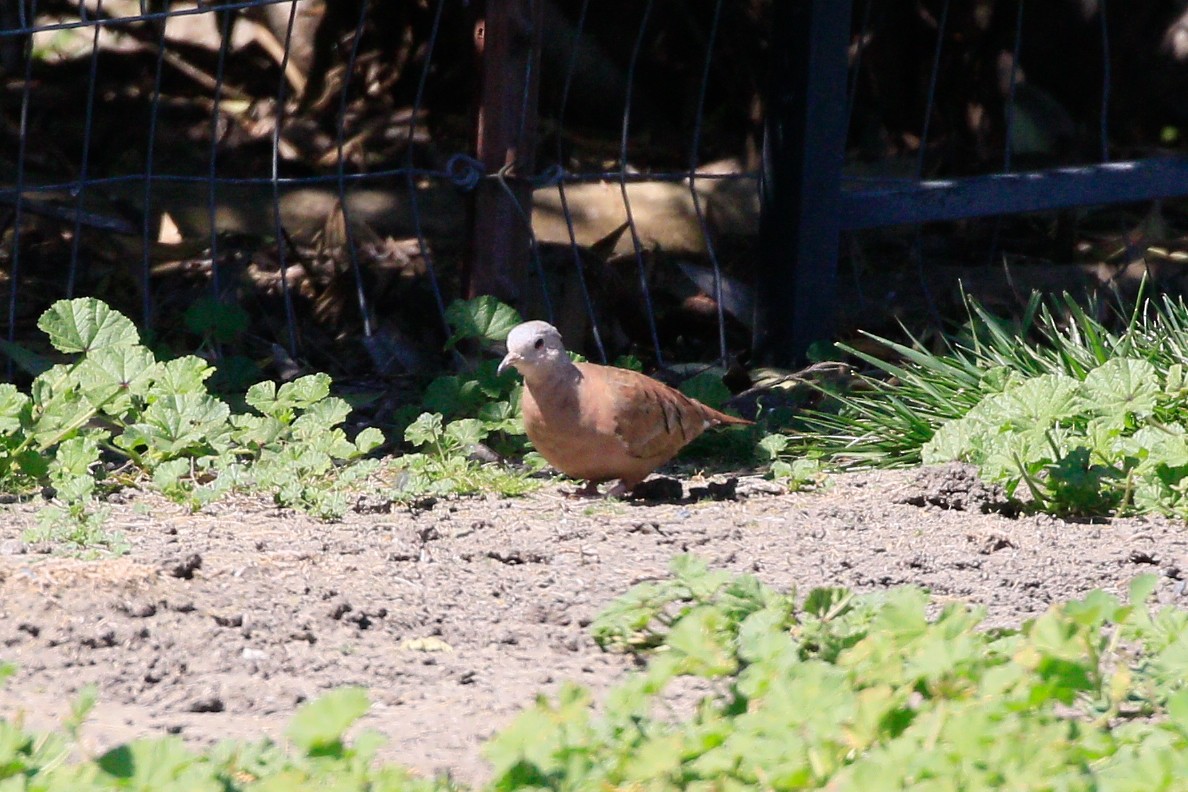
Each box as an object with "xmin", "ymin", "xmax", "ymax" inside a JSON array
[{"xmin": 0, "ymin": 298, "xmax": 384, "ymax": 541}]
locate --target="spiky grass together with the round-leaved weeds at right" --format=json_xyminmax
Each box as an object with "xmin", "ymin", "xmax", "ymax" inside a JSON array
[{"xmin": 794, "ymin": 294, "xmax": 1188, "ymax": 518}]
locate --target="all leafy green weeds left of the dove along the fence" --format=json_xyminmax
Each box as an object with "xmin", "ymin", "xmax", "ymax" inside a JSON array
[{"xmin": 0, "ymin": 298, "xmax": 544, "ymax": 550}]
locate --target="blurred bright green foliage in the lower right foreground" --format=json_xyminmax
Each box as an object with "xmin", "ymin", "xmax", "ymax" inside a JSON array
[{"xmin": 488, "ymin": 558, "xmax": 1188, "ymax": 790}]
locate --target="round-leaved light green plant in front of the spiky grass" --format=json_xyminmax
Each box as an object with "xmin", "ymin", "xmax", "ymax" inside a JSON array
[{"xmin": 923, "ymin": 357, "xmax": 1188, "ymax": 518}]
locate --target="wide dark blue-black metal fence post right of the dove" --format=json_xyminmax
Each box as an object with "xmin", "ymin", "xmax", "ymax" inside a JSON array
[{"xmin": 754, "ymin": 0, "xmax": 851, "ymax": 365}]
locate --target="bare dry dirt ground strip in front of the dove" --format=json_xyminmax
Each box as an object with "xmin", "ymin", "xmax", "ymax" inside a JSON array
[{"xmin": 0, "ymin": 467, "xmax": 1188, "ymax": 781}]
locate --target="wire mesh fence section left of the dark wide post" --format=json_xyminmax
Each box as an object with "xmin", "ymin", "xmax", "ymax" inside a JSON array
[{"xmin": 0, "ymin": 0, "xmax": 762, "ymax": 387}]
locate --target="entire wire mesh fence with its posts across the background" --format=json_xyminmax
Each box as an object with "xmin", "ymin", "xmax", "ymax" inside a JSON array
[{"xmin": 0, "ymin": 0, "xmax": 1188, "ymax": 387}]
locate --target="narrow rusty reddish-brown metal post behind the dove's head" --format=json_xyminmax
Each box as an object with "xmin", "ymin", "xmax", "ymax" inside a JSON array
[{"xmin": 465, "ymin": 0, "xmax": 543, "ymax": 305}]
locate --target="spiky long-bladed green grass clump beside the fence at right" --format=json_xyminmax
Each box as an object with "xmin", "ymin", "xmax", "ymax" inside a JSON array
[{"xmin": 791, "ymin": 293, "xmax": 1145, "ymax": 468}]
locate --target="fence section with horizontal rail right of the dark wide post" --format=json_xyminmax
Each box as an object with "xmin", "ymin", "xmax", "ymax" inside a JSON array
[{"xmin": 807, "ymin": 0, "xmax": 1188, "ymax": 356}]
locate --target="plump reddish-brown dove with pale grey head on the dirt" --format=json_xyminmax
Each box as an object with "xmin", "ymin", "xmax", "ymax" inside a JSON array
[{"xmin": 499, "ymin": 322, "xmax": 752, "ymax": 495}]
